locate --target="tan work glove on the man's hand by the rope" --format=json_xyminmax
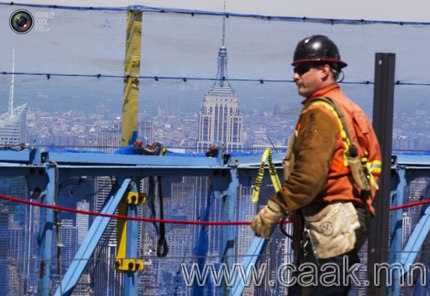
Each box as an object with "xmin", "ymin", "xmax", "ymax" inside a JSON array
[{"xmin": 251, "ymin": 199, "xmax": 284, "ymax": 238}]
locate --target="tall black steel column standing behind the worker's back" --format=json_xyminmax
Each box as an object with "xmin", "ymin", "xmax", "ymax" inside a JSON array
[{"xmin": 367, "ymin": 53, "xmax": 396, "ymax": 296}]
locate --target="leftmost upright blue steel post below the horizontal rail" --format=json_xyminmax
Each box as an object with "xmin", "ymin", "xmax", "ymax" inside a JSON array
[{"xmin": 37, "ymin": 163, "xmax": 58, "ymax": 296}]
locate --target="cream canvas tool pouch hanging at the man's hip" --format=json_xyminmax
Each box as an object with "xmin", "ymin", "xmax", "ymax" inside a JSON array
[{"xmin": 302, "ymin": 202, "xmax": 367, "ymax": 259}]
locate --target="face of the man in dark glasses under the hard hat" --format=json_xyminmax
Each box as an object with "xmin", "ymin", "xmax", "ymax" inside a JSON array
[{"xmin": 293, "ymin": 63, "xmax": 327, "ymax": 98}]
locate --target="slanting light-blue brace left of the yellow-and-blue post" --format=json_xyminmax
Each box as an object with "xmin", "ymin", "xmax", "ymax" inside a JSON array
[{"xmin": 55, "ymin": 179, "xmax": 131, "ymax": 296}]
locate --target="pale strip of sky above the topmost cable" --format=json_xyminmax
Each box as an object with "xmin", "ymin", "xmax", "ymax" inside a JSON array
[{"xmin": 10, "ymin": 0, "xmax": 430, "ymax": 22}]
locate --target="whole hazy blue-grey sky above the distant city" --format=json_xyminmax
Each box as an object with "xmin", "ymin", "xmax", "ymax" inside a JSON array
[{"xmin": 0, "ymin": 0, "xmax": 430, "ymax": 118}]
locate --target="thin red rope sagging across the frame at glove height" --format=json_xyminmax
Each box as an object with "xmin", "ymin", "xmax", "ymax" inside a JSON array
[{"xmin": 0, "ymin": 194, "xmax": 430, "ymax": 225}]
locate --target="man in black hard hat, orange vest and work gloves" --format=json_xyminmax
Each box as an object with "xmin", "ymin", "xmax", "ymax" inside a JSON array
[{"xmin": 251, "ymin": 35, "xmax": 381, "ymax": 295}]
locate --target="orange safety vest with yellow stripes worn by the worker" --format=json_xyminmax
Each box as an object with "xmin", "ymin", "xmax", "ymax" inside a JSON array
[{"xmin": 296, "ymin": 84, "xmax": 381, "ymax": 216}]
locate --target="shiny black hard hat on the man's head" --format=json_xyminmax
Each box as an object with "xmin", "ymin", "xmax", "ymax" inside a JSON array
[{"xmin": 291, "ymin": 35, "xmax": 347, "ymax": 70}]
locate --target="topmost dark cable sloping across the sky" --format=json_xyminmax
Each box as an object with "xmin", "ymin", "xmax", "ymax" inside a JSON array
[{"xmin": 0, "ymin": 2, "xmax": 430, "ymax": 26}]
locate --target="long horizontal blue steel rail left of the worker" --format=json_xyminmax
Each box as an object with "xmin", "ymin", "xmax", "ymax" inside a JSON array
[{"xmin": 0, "ymin": 149, "xmax": 283, "ymax": 178}]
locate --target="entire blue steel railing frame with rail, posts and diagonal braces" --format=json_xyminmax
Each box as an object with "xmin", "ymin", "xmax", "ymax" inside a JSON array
[{"xmin": 0, "ymin": 150, "xmax": 430, "ymax": 295}]
